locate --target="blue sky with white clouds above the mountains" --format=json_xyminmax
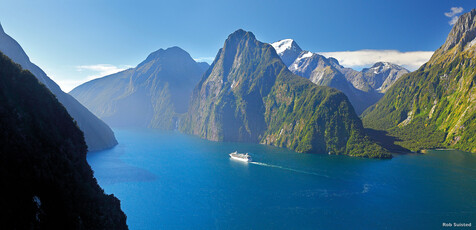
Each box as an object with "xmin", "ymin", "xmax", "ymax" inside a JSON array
[{"xmin": 0, "ymin": 0, "xmax": 476, "ymax": 92}]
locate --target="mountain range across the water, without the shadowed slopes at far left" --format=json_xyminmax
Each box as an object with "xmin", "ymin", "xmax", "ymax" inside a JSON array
[{"xmin": 62, "ymin": 11, "xmax": 475, "ymax": 158}]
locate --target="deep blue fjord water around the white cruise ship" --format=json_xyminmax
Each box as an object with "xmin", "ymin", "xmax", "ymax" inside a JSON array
[{"xmin": 88, "ymin": 129, "xmax": 476, "ymax": 229}]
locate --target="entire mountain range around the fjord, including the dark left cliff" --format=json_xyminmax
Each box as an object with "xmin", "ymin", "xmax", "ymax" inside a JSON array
[{"xmin": 0, "ymin": 6, "xmax": 476, "ymax": 229}]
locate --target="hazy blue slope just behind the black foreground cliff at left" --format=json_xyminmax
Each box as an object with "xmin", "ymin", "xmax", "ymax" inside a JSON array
[{"xmin": 0, "ymin": 22, "xmax": 117, "ymax": 151}]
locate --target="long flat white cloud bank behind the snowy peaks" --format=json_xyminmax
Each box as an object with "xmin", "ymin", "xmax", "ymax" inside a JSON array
[{"xmin": 319, "ymin": 50, "xmax": 433, "ymax": 70}]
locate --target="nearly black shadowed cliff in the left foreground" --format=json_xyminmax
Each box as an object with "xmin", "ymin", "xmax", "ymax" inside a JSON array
[{"xmin": 0, "ymin": 53, "xmax": 127, "ymax": 229}]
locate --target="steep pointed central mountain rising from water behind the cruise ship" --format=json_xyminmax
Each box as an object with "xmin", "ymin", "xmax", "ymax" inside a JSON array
[{"xmin": 180, "ymin": 30, "xmax": 391, "ymax": 158}]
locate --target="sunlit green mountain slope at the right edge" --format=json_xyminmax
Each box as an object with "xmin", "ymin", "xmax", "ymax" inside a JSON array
[{"xmin": 363, "ymin": 9, "xmax": 476, "ymax": 152}]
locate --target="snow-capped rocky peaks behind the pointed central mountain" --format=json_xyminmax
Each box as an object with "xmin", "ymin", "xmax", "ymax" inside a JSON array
[{"xmin": 272, "ymin": 39, "xmax": 408, "ymax": 114}]
